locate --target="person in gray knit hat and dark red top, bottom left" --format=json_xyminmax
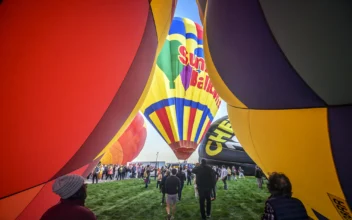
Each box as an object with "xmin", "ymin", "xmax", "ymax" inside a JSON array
[{"xmin": 41, "ymin": 174, "xmax": 97, "ymax": 220}]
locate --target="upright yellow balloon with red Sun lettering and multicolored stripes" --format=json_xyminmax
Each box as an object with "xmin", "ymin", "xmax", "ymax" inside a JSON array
[{"xmin": 141, "ymin": 17, "xmax": 221, "ymax": 160}]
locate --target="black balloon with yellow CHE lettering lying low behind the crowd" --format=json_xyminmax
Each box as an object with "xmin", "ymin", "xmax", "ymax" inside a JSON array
[{"xmin": 198, "ymin": 116, "xmax": 255, "ymax": 175}]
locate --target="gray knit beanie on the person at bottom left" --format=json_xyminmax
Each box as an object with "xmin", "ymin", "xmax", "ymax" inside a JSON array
[{"xmin": 53, "ymin": 174, "xmax": 84, "ymax": 199}]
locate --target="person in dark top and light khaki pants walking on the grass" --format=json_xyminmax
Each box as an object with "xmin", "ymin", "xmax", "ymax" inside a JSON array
[{"xmin": 165, "ymin": 169, "xmax": 181, "ymax": 220}]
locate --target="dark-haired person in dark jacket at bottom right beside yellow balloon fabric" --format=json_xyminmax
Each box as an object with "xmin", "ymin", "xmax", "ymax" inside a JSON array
[{"xmin": 262, "ymin": 173, "xmax": 309, "ymax": 220}]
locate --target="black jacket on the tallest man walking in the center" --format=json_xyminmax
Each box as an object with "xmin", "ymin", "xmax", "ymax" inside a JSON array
[{"xmin": 192, "ymin": 165, "xmax": 216, "ymax": 189}]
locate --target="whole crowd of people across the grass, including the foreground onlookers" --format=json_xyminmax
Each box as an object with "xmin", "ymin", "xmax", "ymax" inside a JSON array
[{"xmin": 41, "ymin": 160, "xmax": 309, "ymax": 220}]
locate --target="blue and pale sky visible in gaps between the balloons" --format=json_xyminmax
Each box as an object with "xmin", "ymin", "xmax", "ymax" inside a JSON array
[{"xmin": 134, "ymin": 0, "xmax": 227, "ymax": 162}]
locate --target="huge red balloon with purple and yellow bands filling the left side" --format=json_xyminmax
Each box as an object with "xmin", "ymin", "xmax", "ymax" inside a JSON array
[{"xmin": 0, "ymin": 0, "xmax": 175, "ymax": 220}]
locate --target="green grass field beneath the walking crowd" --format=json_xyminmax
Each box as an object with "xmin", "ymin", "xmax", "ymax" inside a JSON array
[{"xmin": 86, "ymin": 177, "xmax": 269, "ymax": 220}]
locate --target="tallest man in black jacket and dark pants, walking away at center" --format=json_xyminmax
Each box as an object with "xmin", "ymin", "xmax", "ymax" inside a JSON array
[{"xmin": 192, "ymin": 159, "xmax": 215, "ymax": 219}]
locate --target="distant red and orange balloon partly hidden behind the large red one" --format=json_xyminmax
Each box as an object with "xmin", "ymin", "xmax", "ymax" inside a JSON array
[{"xmin": 101, "ymin": 113, "xmax": 147, "ymax": 165}]
